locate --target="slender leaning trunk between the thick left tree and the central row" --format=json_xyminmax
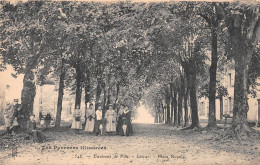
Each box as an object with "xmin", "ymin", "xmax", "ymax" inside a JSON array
[{"xmin": 55, "ymin": 59, "xmax": 66, "ymax": 128}]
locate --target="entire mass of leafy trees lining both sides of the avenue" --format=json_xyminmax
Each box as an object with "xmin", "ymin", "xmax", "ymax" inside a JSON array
[{"xmin": 0, "ymin": 1, "xmax": 260, "ymax": 139}]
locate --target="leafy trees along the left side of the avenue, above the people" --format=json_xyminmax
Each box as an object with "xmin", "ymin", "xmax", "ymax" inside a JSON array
[{"xmin": 1, "ymin": 1, "xmax": 144, "ymax": 127}]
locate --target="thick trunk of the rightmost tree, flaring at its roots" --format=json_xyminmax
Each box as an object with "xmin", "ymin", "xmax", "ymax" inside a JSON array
[{"xmin": 229, "ymin": 14, "xmax": 259, "ymax": 139}]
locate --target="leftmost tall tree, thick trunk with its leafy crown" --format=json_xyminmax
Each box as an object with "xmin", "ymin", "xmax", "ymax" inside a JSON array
[{"xmin": 1, "ymin": 1, "xmax": 48, "ymax": 120}]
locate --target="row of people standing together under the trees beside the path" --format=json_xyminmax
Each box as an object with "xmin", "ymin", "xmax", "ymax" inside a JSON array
[{"xmin": 71, "ymin": 103, "xmax": 133, "ymax": 136}]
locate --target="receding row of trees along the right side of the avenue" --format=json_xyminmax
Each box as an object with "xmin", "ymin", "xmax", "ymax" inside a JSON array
[{"xmin": 140, "ymin": 3, "xmax": 260, "ymax": 137}]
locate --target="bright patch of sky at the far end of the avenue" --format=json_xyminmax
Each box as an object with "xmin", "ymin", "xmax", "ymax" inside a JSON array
[{"xmin": 133, "ymin": 104, "xmax": 154, "ymax": 123}]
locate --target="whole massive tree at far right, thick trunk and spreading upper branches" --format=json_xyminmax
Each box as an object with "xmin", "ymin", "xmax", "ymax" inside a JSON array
[{"xmin": 219, "ymin": 3, "xmax": 260, "ymax": 139}]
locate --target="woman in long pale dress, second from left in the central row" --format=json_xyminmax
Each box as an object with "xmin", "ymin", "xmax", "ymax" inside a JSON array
[{"xmin": 85, "ymin": 103, "xmax": 96, "ymax": 132}]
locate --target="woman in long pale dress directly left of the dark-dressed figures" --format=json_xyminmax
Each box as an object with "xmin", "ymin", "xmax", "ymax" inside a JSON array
[{"xmin": 105, "ymin": 104, "xmax": 117, "ymax": 133}]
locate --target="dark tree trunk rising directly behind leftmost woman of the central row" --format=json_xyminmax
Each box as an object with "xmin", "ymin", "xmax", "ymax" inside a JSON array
[{"xmin": 75, "ymin": 66, "xmax": 82, "ymax": 108}]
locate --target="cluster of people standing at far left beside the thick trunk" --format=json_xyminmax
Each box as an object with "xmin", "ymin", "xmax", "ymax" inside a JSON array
[{"xmin": 4, "ymin": 99, "xmax": 23, "ymax": 135}]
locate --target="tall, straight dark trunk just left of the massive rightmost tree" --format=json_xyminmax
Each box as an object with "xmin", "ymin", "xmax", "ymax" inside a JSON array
[{"xmin": 207, "ymin": 16, "xmax": 218, "ymax": 128}]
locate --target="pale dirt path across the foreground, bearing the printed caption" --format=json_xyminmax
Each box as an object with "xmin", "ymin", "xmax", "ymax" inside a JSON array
[{"xmin": 0, "ymin": 124, "xmax": 260, "ymax": 165}]
